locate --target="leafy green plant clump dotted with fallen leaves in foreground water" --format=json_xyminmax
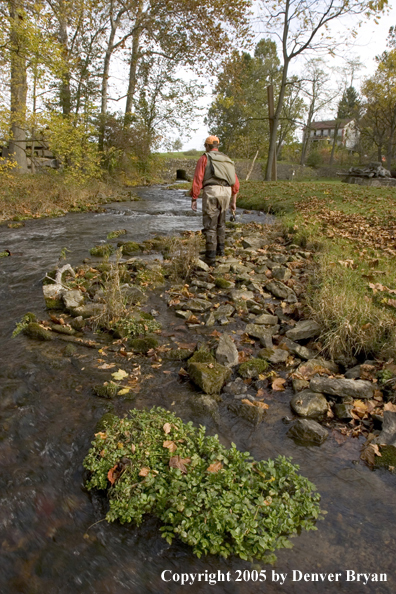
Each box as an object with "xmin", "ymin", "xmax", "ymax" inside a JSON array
[{"xmin": 84, "ymin": 408, "xmax": 321, "ymax": 561}]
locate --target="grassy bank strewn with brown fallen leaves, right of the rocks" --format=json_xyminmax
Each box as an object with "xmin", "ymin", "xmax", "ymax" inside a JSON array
[{"xmin": 238, "ymin": 182, "xmax": 396, "ymax": 358}]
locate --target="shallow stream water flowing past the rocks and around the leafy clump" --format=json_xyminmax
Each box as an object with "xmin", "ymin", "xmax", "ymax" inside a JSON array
[{"xmin": 0, "ymin": 187, "xmax": 396, "ymax": 594}]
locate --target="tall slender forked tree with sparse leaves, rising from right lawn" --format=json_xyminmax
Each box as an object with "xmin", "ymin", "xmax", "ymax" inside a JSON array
[{"xmin": 261, "ymin": 0, "xmax": 388, "ymax": 180}]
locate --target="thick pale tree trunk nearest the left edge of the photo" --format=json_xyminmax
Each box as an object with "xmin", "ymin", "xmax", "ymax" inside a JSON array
[{"xmin": 9, "ymin": 0, "xmax": 27, "ymax": 173}]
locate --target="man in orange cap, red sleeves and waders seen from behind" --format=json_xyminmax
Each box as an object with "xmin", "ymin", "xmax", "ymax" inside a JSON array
[{"xmin": 190, "ymin": 136, "xmax": 239, "ymax": 266}]
